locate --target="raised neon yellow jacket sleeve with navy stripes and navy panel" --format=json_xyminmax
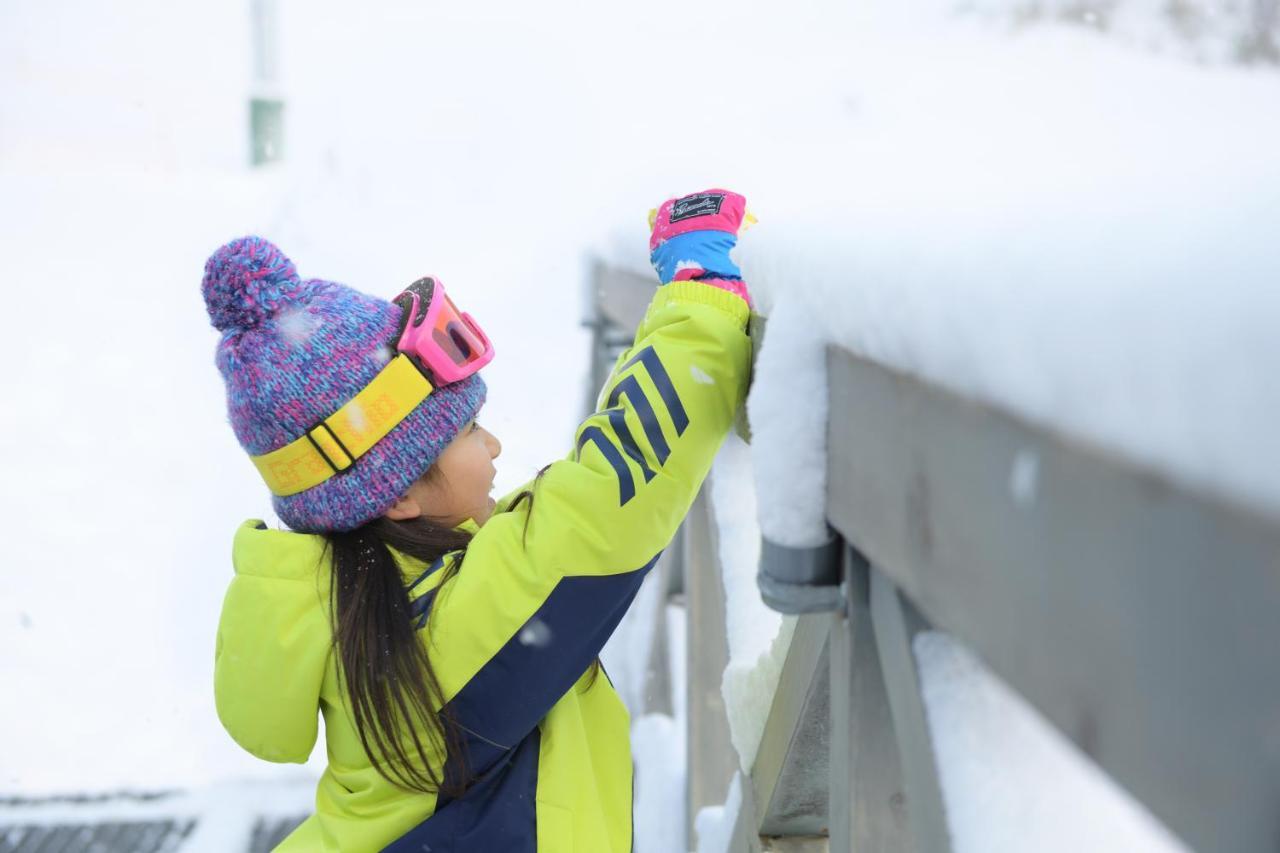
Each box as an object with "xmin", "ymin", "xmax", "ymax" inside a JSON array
[{"xmin": 422, "ymin": 282, "xmax": 750, "ymax": 747}]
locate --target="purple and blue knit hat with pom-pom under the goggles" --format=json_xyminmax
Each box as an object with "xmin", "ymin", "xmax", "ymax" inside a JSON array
[{"xmin": 201, "ymin": 237, "xmax": 485, "ymax": 533}]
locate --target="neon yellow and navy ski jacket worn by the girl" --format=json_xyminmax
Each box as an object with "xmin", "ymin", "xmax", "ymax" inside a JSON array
[{"xmin": 214, "ymin": 282, "xmax": 750, "ymax": 853}]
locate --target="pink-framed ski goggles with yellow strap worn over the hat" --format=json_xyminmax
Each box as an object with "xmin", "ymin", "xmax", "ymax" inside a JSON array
[{"xmin": 250, "ymin": 278, "xmax": 494, "ymax": 497}]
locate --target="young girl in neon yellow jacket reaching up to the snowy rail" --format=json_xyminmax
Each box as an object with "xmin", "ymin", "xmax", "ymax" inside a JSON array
[{"xmin": 201, "ymin": 190, "xmax": 750, "ymax": 853}]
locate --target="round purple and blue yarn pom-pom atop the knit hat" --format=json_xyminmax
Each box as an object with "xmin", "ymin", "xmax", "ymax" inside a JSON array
[{"xmin": 200, "ymin": 237, "xmax": 303, "ymax": 332}]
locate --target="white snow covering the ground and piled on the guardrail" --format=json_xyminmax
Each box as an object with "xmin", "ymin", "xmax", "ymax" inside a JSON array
[{"xmin": 0, "ymin": 0, "xmax": 1280, "ymax": 850}]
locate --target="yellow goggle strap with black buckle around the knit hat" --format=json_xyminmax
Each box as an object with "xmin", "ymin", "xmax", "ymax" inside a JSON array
[{"xmin": 250, "ymin": 353, "xmax": 435, "ymax": 497}]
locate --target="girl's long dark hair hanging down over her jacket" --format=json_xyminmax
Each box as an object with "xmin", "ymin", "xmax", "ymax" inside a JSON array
[{"xmin": 324, "ymin": 465, "xmax": 599, "ymax": 798}]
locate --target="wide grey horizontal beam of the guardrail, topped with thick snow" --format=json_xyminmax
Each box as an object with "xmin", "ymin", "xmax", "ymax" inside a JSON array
[{"xmin": 827, "ymin": 350, "xmax": 1280, "ymax": 852}]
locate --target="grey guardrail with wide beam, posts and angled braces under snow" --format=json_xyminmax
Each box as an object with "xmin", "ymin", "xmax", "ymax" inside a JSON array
[{"xmin": 593, "ymin": 265, "xmax": 1280, "ymax": 853}]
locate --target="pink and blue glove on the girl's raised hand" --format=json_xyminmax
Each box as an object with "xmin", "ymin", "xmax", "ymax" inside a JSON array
[{"xmin": 649, "ymin": 190, "xmax": 754, "ymax": 306}]
